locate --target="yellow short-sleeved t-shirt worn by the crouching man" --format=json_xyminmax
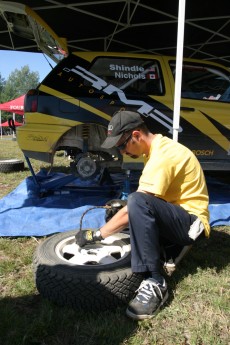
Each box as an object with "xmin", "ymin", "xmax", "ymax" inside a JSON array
[{"xmin": 139, "ymin": 134, "xmax": 210, "ymax": 237}]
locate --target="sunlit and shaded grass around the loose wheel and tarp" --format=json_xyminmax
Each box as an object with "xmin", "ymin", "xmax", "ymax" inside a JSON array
[{"xmin": 0, "ymin": 139, "xmax": 230, "ymax": 345}]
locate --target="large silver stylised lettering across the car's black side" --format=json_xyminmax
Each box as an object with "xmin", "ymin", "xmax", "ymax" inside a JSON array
[{"xmin": 63, "ymin": 65, "xmax": 183, "ymax": 133}]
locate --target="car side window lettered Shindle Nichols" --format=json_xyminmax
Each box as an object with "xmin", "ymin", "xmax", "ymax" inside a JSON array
[{"xmin": 89, "ymin": 57, "xmax": 164, "ymax": 95}]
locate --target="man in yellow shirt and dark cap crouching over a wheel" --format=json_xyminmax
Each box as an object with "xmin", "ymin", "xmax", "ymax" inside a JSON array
[{"xmin": 76, "ymin": 111, "xmax": 210, "ymax": 320}]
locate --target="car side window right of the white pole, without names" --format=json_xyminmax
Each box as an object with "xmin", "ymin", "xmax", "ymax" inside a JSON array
[{"xmin": 170, "ymin": 62, "xmax": 230, "ymax": 102}]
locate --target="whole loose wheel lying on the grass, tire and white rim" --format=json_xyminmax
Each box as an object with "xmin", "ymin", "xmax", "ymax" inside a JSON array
[{"xmin": 33, "ymin": 230, "xmax": 143, "ymax": 311}]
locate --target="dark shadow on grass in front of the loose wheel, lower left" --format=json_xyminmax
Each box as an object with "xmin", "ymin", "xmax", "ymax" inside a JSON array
[{"xmin": 0, "ymin": 295, "xmax": 137, "ymax": 345}]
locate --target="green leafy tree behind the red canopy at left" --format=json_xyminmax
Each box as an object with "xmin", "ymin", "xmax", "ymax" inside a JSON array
[{"xmin": 1, "ymin": 65, "xmax": 39, "ymax": 103}]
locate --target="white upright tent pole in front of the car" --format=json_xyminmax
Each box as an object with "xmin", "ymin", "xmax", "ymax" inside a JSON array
[{"xmin": 173, "ymin": 0, "xmax": 186, "ymax": 141}]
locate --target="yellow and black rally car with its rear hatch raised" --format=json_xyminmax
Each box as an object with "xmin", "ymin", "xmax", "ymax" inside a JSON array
[{"xmin": 1, "ymin": 5, "xmax": 230, "ymax": 177}]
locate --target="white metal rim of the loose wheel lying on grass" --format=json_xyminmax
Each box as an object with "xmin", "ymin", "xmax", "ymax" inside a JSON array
[{"xmin": 55, "ymin": 234, "xmax": 131, "ymax": 266}]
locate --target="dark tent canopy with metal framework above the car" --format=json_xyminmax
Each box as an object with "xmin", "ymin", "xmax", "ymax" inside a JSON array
[{"xmin": 0, "ymin": 0, "xmax": 230, "ymax": 66}]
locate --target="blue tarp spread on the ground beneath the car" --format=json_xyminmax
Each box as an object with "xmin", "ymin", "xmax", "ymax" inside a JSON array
[{"xmin": 0, "ymin": 172, "xmax": 230, "ymax": 236}]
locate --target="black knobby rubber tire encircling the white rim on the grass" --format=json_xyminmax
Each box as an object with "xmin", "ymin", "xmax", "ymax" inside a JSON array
[{"xmin": 34, "ymin": 230, "xmax": 143, "ymax": 311}]
